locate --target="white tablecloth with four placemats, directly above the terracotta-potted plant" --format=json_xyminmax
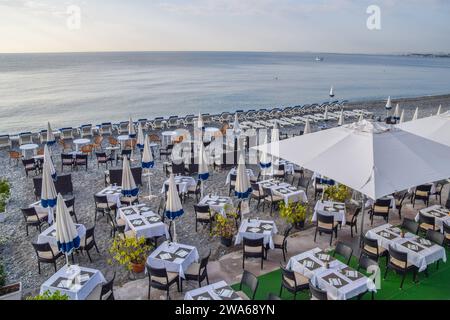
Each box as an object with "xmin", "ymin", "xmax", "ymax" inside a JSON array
[{"xmin": 117, "ymin": 204, "xmax": 169, "ymax": 239}]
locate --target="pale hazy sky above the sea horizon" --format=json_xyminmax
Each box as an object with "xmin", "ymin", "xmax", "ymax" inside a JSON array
[{"xmin": 0, "ymin": 0, "xmax": 450, "ymax": 53}]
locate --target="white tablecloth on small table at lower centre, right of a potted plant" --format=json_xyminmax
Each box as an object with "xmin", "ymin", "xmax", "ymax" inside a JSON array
[{"xmin": 234, "ymin": 219, "xmax": 278, "ymax": 249}]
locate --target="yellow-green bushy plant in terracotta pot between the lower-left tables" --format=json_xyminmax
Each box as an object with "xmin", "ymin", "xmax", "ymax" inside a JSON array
[{"xmin": 109, "ymin": 236, "xmax": 151, "ymax": 273}]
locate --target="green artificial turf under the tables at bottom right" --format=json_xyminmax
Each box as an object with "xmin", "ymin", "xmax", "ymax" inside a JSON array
[{"xmin": 232, "ymin": 249, "xmax": 450, "ymax": 300}]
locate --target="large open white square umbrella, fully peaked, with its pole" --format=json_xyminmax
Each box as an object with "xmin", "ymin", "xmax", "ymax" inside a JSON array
[{"xmin": 256, "ymin": 120, "xmax": 450, "ymax": 234}]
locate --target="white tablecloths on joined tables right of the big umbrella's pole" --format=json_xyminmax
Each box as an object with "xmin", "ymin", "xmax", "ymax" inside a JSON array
[{"xmin": 366, "ymin": 223, "xmax": 447, "ymax": 272}]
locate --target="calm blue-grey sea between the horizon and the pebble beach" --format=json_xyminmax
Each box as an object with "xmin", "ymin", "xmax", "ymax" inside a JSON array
[{"xmin": 0, "ymin": 52, "xmax": 450, "ymax": 133}]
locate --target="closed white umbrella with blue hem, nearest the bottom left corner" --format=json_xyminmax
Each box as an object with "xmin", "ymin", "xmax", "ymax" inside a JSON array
[{"xmin": 56, "ymin": 193, "xmax": 80, "ymax": 265}]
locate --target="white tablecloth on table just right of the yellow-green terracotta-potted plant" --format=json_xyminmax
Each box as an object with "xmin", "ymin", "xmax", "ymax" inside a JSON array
[{"xmin": 147, "ymin": 241, "xmax": 199, "ymax": 278}]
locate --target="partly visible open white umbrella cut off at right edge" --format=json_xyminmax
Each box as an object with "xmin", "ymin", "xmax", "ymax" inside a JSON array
[{"xmin": 397, "ymin": 111, "xmax": 450, "ymax": 146}]
